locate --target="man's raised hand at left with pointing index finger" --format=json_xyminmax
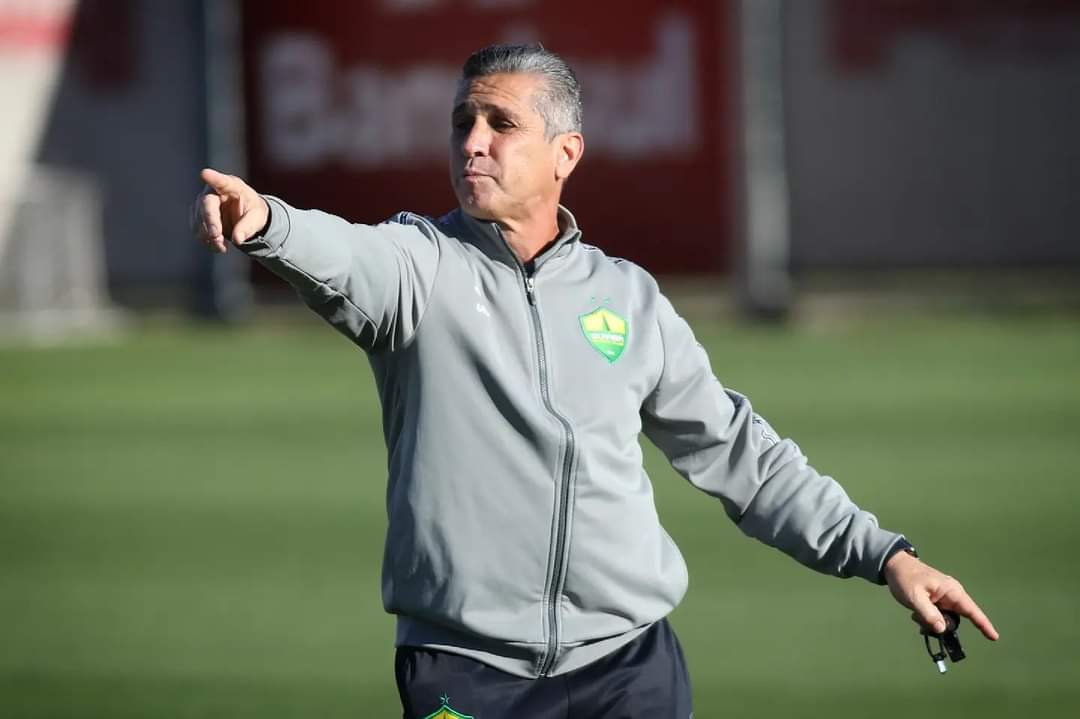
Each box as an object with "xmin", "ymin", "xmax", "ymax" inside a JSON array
[{"xmin": 191, "ymin": 167, "xmax": 270, "ymax": 253}]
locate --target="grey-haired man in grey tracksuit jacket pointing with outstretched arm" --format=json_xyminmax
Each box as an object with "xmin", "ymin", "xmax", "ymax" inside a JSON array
[{"xmin": 197, "ymin": 45, "xmax": 997, "ymax": 719}]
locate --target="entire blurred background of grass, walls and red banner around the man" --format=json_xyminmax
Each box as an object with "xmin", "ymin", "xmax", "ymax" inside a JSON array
[{"xmin": 0, "ymin": 0, "xmax": 1080, "ymax": 717}]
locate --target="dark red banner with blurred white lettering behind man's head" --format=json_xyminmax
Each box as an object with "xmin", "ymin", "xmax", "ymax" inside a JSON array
[{"xmin": 243, "ymin": 0, "xmax": 733, "ymax": 272}]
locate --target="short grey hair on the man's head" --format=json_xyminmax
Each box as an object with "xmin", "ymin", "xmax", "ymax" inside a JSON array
[{"xmin": 461, "ymin": 44, "xmax": 582, "ymax": 139}]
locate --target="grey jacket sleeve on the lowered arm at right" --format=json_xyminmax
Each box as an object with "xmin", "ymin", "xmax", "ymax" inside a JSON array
[{"xmin": 642, "ymin": 297, "xmax": 900, "ymax": 584}]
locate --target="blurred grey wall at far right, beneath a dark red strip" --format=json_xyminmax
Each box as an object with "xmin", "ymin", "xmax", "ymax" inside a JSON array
[{"xmin": 786, "ymin": 0, "xmax": 1080, "ymax": 267}]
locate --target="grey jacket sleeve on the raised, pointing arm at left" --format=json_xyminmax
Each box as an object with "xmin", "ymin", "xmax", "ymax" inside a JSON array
[{"xmin": 242, "ymin": 195, "xmax": 440, "ymax": 352}]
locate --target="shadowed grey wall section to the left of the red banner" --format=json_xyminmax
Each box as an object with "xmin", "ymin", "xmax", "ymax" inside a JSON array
[{"xmin": 38, "ymin": 0, "xmax": 205, "ymax": 290}]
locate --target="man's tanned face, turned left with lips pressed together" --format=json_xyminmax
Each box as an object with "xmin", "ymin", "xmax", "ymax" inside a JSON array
[{"xmin": 450, "ymin": 73, "xmax": 561, "ymax": 221}]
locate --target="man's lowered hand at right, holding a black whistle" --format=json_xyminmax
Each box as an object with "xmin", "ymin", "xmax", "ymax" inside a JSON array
[{"xmin": 885, "ymin": 552, "xmax": 998, "ymax": 639}]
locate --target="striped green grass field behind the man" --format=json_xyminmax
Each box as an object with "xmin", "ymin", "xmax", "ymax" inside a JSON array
[{"xmin": 0, "ymin": 308, "xmax": 1080, "ymax": 719}]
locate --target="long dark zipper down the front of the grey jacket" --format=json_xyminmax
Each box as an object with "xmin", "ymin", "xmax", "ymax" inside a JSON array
[{"xmin": 495, "ymin": 225, "xmax": 575, "ymax": 676}]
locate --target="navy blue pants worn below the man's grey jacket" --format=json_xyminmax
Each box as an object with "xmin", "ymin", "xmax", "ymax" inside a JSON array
[{"xmin": 394, "ymin": 620, "xmax": 693, "ymax": 719}]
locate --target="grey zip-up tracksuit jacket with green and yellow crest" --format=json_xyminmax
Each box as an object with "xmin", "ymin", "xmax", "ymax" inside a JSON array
[{"xmin": 243, "ymin": 198, "xmax": 900, "ymax": 677}]
